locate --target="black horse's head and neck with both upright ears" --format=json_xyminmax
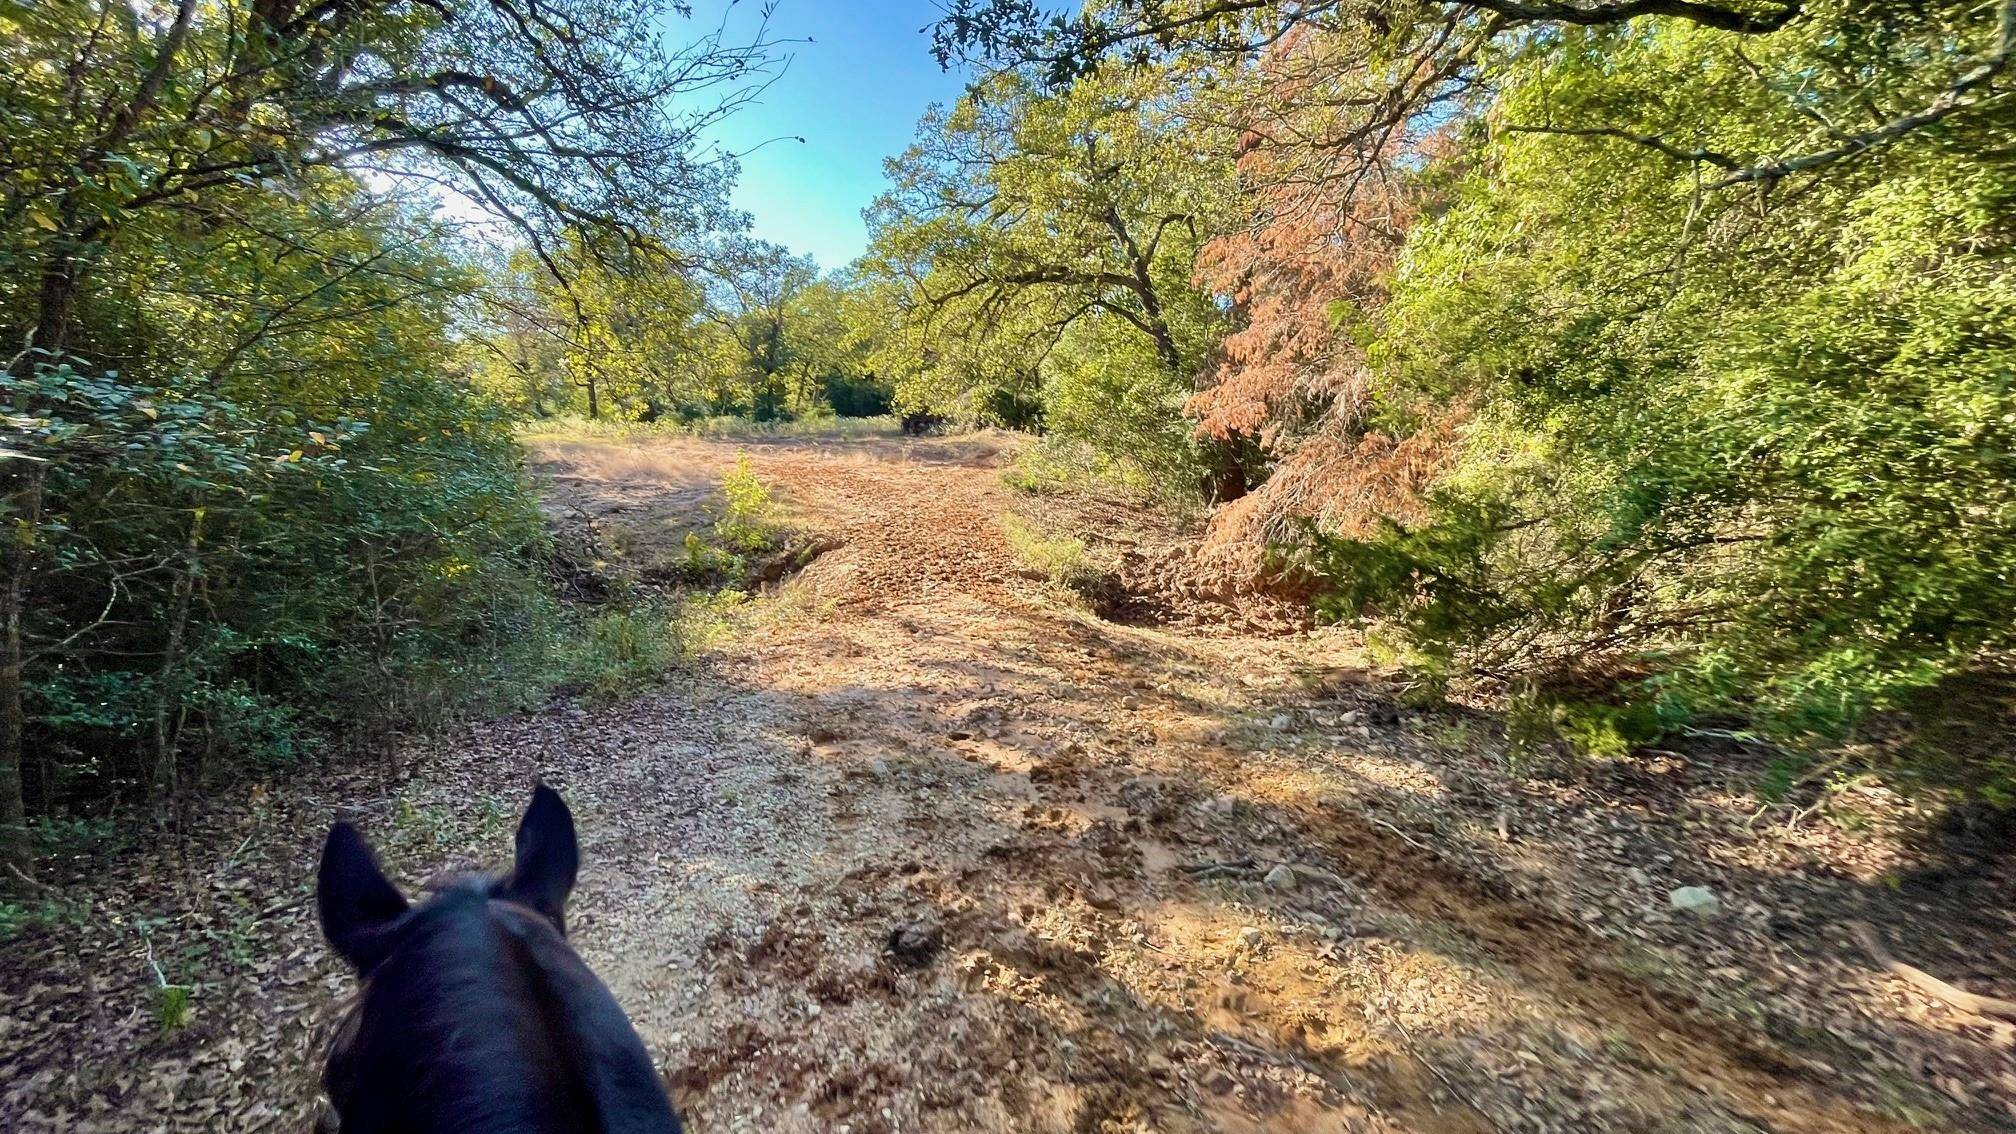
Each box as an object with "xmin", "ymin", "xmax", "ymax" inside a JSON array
[{"xmin": 314, "ymin": 785, "xmax": 679, "ymax": 1134}]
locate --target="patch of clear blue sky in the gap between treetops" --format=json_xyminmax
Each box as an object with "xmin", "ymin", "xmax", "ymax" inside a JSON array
[{"xmin": 669, "ymin": 0, "xmax": 964, "ymax": 270}]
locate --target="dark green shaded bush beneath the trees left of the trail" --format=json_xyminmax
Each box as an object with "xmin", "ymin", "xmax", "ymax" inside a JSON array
[{"xmin": 0, "ymin": 353, "xmax": 548, "ymax": 811}]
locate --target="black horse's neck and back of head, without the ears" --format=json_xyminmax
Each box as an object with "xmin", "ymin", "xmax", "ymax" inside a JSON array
[{"xmin": 327, "ymin": 886, "xmax": 679, "ymax": 1134}]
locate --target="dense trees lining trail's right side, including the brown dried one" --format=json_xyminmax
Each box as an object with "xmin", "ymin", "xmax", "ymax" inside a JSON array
[{"xmin": 915, "ymin": 0, "xmax": 2016, "ymax": 799}]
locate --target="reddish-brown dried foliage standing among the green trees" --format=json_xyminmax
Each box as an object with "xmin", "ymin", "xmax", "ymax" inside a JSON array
[{"xmin": 1187, "ymin": 34, "xmax": 1464, "ymax": 587}]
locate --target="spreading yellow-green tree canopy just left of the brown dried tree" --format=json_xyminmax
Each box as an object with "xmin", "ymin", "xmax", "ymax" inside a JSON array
[{"xmin": 865, "ymin": 73, "xmax": 1232, "ymax": 490}]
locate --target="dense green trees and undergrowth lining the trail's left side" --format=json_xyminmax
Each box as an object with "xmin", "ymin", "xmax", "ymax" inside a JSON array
[{"xmin": 0, "ymin": 0, "xmax": 768, "ymax": 882}]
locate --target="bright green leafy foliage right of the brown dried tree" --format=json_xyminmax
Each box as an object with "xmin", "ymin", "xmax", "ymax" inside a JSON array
[{"xmin": 1306, "ymin": 6, "xmax": 2016, "ymax": 789}]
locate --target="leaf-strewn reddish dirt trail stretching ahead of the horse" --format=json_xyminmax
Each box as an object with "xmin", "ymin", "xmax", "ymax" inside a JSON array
[{"xmin": 0, "ymin": 427, "xmax": 2016, "ymax": 1134}]
